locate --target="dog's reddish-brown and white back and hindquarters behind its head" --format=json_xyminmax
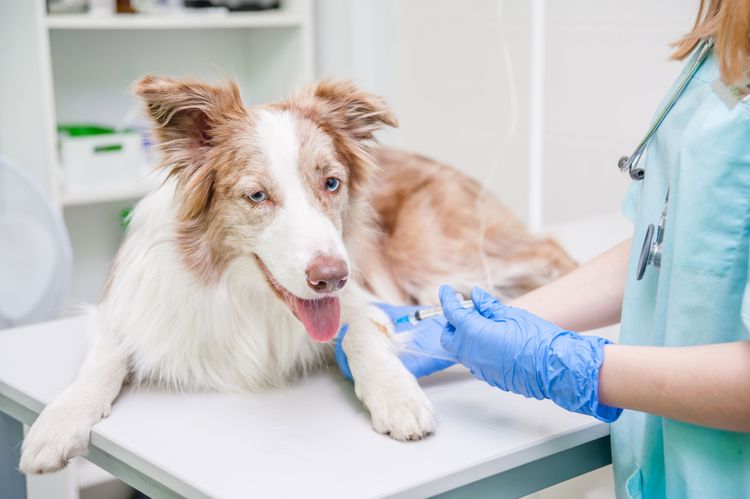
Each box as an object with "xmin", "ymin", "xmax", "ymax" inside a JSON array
[{"xmin": 365, "ymin": 148, "xmax": 575, "ymax": 304}]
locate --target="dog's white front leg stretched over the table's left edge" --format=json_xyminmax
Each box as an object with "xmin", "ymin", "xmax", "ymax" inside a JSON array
[{"xmin": 20, "ymin": 316, "xmax": 128, "ymax": 473}]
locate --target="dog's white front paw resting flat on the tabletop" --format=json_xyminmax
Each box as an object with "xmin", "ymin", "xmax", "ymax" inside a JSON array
[{"xmin": 362, "ymin": 379, "xmax": 435, "ymax": 441}]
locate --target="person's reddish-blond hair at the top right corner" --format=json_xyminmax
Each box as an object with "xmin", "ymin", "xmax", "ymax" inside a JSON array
[{"xmin": 672, "ymin": 0, "xmax": 750, "ymax": 83}]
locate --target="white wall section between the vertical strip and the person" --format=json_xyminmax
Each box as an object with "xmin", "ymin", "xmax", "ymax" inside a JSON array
[{"xmin": 542, "ymin": 0, "xmax": 697, "ymax": 224}]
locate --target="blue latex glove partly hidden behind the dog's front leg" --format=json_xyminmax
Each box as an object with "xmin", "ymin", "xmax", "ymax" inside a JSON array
[{"xmin": 336, "ymin": 303, "xmax": 458, "ymax": 381}]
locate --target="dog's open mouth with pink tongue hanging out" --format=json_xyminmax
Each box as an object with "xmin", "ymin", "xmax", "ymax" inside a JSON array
[{"xmin": 255, "ymin": 255, "xmax": 341, "ymax": 343}]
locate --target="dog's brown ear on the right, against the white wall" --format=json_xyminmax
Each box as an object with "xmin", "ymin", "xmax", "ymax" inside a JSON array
[{"xmin": 311, "ymin": 80, "xmax": 398, "ymax": 141}]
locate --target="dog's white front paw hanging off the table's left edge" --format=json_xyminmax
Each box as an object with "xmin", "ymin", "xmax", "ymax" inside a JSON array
[{"xmin": 20, "ymin": 404, "xmax": 92, "ymax": 474}]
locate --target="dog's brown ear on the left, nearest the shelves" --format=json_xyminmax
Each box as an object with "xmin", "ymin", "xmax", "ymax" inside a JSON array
[{"xmin": 133, "ymin": 75, "xmax": 247, "ymax": 219}]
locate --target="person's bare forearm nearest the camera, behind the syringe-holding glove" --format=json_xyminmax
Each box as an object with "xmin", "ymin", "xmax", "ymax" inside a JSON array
[{"xmin": 599, "ymin": 341, "xmax": 750, "ymax": 432}]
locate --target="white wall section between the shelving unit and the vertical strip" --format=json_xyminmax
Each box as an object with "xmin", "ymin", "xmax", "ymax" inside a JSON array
[{"xmin": 317, "ymin": 0, "xmax": 530, "ymax": 221}]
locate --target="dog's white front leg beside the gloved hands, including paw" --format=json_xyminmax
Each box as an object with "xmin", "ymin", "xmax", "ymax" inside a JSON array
[{"xmin": 342, "ymin": 292, "xmax": 435, "ymax": 440}]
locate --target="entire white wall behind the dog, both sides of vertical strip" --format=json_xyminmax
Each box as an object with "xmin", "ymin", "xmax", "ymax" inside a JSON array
[{"xmin": 317, "ymin": 0, "xmax": 697, "ymax": 225}]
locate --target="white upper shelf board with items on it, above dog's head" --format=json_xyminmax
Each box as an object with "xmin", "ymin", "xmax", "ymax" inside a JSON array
[{"xmin": 45, "ymin": 10, "xmax": 304, "ymax": 30}]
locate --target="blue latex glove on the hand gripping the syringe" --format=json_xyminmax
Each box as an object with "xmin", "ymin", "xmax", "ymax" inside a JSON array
[{"xmin": 440, "ymin": 286, "xmax": 622, "ymax": 423}]
